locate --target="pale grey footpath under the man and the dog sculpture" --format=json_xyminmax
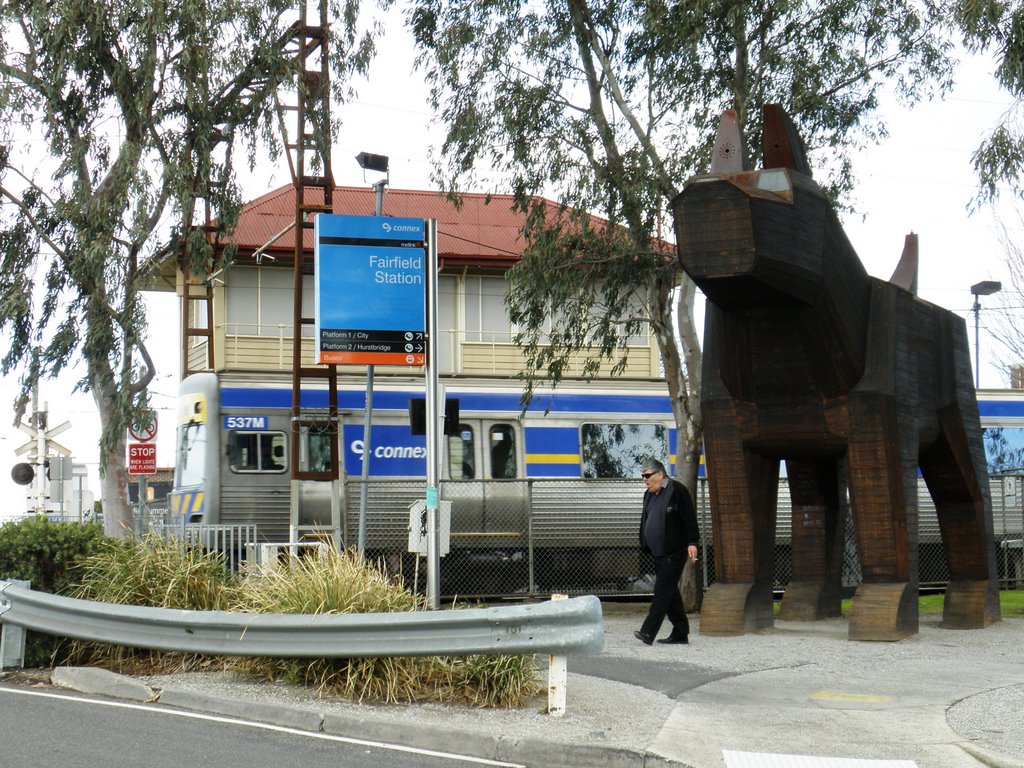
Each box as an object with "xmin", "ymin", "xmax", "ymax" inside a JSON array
[{"xmin": 32, "ymin": 604, "xmax": 1024, "ymax": 768}]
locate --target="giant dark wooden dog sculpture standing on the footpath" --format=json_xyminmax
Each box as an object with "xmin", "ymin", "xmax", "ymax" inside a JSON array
[{"xmin": 673, "ymin": 104, "xmax": 999, "ymax": 640}]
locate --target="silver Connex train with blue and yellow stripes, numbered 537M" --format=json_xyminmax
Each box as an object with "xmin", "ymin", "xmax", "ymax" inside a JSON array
[{"xmin": 170, "ymin": 374, "xmax": 1024, "ymax": 595}]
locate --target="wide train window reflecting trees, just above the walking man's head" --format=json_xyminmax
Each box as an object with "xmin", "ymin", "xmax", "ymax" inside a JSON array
[{"xmin": 580, "ymin": 424, "xmax": 669, "ymax": 477}]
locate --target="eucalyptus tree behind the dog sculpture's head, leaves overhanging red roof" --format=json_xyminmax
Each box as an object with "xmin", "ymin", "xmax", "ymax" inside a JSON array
[{"xmin": 409, "ymin": 0, "xmax": 952, "ymax": 487}]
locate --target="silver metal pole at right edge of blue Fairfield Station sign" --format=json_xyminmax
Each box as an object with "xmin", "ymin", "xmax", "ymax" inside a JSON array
[{"xmin": 425, "ymin": 219, "xmax": 441, "ymax": 610}]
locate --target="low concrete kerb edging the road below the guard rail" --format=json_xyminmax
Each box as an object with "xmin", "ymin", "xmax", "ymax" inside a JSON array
[{"xmin": 51, "ymin": 667, "xmax": 694, "ymax": 768}]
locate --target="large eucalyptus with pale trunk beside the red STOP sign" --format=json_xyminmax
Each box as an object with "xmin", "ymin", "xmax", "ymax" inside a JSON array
[{"xmin": 0, "ymin": 0, "xmax": 372, "ymax": 535}]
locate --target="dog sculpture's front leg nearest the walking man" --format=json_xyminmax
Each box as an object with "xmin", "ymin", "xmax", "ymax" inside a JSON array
[{"xmin": 700, "ymin": 400, "xmax": 779, "ymax": 635}]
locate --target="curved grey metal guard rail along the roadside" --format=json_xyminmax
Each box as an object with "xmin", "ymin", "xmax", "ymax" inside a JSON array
[{"xmin": 0, "ymin": 580, "xmax": 604, "ymax": 658}]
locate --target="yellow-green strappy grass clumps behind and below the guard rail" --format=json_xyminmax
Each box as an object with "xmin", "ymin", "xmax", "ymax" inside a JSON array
[{"xmin": 37, "ymin": 538, "xmax": 540, "ymax": 707}]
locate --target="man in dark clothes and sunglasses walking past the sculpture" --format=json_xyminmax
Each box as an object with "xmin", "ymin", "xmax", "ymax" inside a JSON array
[{"xmin": 633, "ymin": 459, "xmax": 700, "ymax": 645}]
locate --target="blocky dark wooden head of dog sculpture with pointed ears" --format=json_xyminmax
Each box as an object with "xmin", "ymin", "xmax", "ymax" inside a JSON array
[{"xmin": 673, "ymin": 104, "xmax": 866, "ymax": 309}]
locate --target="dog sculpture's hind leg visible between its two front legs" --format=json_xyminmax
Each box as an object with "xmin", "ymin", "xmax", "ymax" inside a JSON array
[{"xmin": 779, "ymin": 458, "xmax": 847, "ymax": 622}]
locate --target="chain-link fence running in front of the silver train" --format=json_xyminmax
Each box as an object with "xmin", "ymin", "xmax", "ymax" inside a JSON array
[{"xmin": 344, "ymin": 476, "xmax": 1024, "ymax": 598}]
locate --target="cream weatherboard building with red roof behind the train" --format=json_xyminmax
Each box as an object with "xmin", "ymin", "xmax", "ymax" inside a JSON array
[{"xmin": 153, "ymin": 184, "xmax": 660, "ymax": 380}]
